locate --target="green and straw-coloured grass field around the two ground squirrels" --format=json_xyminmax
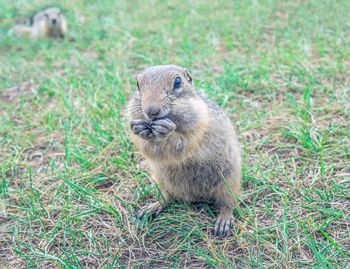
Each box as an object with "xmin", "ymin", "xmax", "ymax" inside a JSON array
[{"xmin": 0, "ymin": 0, "xmax": 350, "ymax": 268}]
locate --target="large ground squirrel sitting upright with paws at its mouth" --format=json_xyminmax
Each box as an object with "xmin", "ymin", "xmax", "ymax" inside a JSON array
[{"xmin": 127, "ymin": 65, "xmax": 241, "ymax": 237}]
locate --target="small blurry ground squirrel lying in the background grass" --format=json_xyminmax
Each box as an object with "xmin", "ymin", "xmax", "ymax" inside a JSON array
[{"xmin": 9, "ymin": 7, "xmax": 67, "ymax": 37}]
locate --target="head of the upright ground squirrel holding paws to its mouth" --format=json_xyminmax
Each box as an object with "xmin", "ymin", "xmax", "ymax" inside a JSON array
[{"xmin": 137, "ymin": 65, "xmax": 196, "ymax": 120}]
